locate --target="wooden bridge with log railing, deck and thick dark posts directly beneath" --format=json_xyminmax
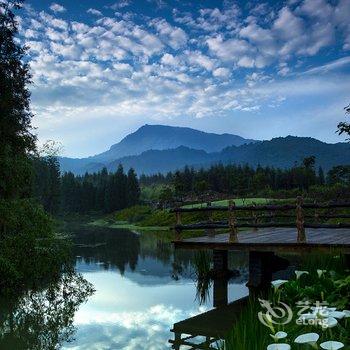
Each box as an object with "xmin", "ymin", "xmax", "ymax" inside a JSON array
[{"xmin": 172, "ymin": 197, "xmax": 350, "ymax": 288}]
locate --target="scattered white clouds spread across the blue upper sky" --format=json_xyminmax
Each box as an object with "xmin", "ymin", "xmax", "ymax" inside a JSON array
[{"xmin": 20, "ymin": 0, "xmax": 350, "ymax": 156}]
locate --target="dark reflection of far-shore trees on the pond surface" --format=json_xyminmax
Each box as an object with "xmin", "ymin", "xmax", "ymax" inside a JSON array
[{"xmin": 74, "ymin": 226, "xmax": 246, "ymax": 279}]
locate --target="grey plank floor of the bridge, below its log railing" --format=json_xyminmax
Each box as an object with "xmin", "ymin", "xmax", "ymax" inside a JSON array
[{"xmin": 173, "ymin": 228, "xmax": 350, "ymax": 253}]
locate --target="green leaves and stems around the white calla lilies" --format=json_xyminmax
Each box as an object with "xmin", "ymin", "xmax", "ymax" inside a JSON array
[{"xmin": 221, "ymin": 256, "xmax": 350, "ymax": 350}]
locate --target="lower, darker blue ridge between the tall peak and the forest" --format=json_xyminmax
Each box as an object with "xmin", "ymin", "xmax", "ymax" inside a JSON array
[{"xmin": 72, "ymin": 136, "xmax": 350, "ymax": 174}]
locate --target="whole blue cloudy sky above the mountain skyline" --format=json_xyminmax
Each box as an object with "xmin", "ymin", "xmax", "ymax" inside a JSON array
[{"xmin": 17, "ymin": 0, "xmax": 350, "ymax": 157}]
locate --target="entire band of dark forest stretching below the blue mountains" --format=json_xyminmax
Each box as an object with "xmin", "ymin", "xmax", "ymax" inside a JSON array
[{"xmin": 32, "ymin": 156, "xmax": 350, "ymax": 219}]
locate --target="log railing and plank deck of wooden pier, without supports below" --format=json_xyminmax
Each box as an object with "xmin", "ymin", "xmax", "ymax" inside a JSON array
[{"xmin": 172, "ymin": 197, "xmax": 350, "ymax": 252}]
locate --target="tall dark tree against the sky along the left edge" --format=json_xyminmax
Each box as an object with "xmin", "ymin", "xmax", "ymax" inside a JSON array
[{"xmin": 0, "ymin": 1, "xmax": 36, "ymax": 198}]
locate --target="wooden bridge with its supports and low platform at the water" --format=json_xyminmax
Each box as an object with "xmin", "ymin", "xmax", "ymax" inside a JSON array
[{"xmin": 170, "ymin": 197, "xmax": 350, "ymax": 349}]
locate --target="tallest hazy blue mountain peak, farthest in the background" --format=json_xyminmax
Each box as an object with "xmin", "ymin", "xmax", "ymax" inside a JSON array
[{"xmin": 60, "ymin": 124, "xmax": 257, "ymax": 173}]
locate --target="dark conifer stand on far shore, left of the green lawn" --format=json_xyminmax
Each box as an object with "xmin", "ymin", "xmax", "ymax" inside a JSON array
[{"xmin": 32, "ymin": 156, "xmax": 141, "ymax": 215}]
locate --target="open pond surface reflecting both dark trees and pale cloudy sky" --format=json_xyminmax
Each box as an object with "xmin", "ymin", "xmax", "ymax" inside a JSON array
[{"xmin": 64, "ymin": 228, "xmax": 247, "ymax": 349}]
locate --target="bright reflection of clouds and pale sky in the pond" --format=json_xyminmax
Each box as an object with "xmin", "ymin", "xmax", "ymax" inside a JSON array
[{"xmin": 63, "ymin": 264, "xmax": 247, "ymax": 350}]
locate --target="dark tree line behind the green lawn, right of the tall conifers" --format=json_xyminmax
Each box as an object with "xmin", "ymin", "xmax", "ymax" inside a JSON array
[{"xmin": 140, "ymin": 156, "xmax": 350, "ymax": 199}]
